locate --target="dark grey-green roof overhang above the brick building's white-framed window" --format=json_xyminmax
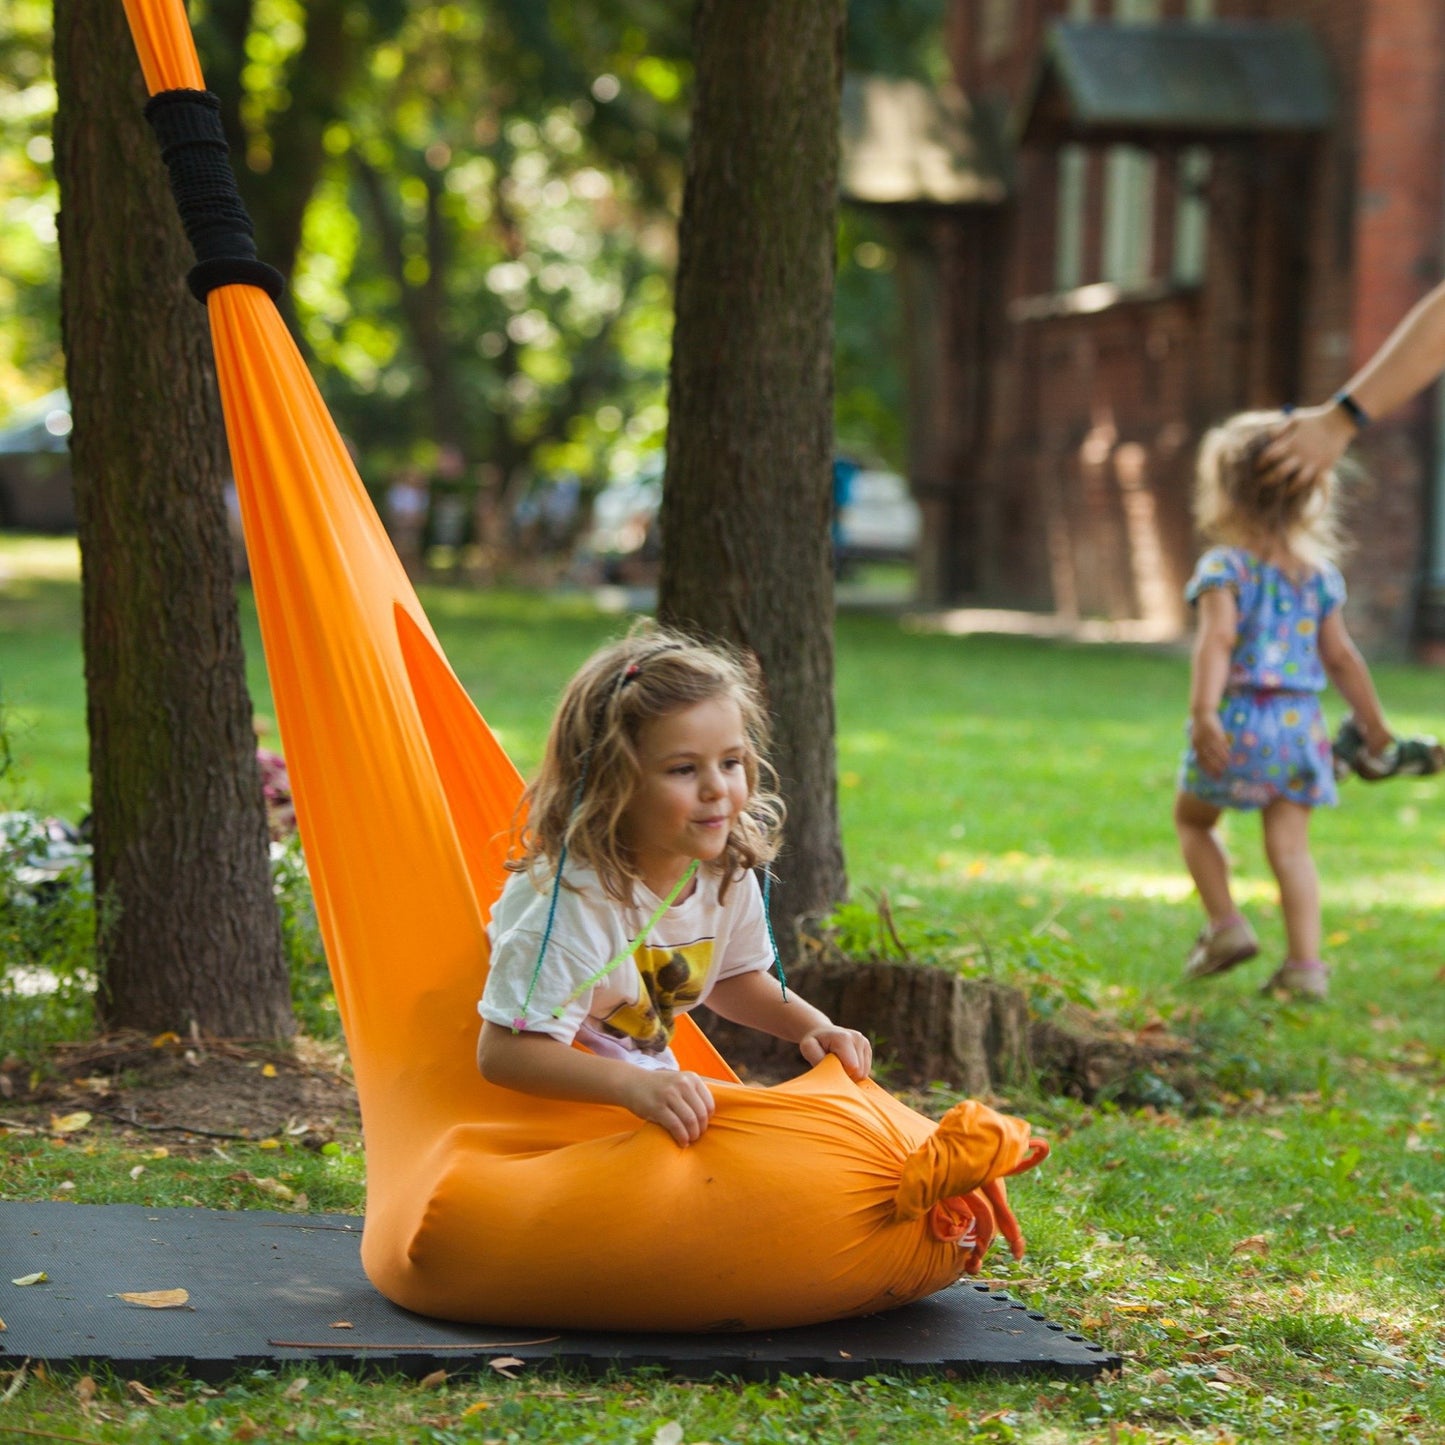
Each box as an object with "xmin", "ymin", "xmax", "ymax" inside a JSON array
[{"xmin": 1014, "ymin": 20, "xmax": 1335, "ymax": 146}]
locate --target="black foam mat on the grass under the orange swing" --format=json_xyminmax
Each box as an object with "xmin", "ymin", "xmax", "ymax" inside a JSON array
[{"xmin": 0, "ymin": 1202, "xmax": 1121, "ymax": 1381}]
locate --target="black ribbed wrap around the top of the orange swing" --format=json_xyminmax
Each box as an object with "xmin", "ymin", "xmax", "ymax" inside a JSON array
[{"xmin": 146, "ymin": 90, "xmax": 286, "ymax": 302}]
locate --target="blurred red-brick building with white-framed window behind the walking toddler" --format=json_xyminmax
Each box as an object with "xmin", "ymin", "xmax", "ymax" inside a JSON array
[{"xmin": 897, "ymin": 0, "xmax": 1445, "ymax": 647}]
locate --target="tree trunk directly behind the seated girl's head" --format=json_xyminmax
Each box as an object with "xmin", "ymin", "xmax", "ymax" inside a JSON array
[{"xmin": 659, "ymin": 0, "xmax": 847, "ymax": 954}]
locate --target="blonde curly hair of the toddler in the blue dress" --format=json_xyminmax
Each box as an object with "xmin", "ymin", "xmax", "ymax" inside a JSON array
[{"xmin": 1194, "ymin": 412, "xmax": 1344, "ymax": 566}]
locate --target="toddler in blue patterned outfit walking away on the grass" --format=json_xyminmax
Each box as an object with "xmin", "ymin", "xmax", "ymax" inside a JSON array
[{"xmin": 1175, "ymin": 412, "xmax": 1393, "ymax": 998}]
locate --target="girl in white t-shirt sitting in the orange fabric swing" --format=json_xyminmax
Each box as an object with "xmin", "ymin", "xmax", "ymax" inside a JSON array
[{"xmin": 477, "ymin": 630, "xmax": 873, "ymax": 1146}]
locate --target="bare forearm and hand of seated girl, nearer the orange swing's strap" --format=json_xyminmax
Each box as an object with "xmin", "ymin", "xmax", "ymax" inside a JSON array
[{"xmin": 477, "ymin": 1020, "xmax": 714, "ymax": 1147}]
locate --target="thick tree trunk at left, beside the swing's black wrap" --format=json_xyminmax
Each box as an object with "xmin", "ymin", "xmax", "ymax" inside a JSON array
[{"xmin": 55, "ymin": 0, "xmax": 293, "ymax": 1038}]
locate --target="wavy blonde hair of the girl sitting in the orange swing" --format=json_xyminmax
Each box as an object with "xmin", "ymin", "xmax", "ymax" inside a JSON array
[{"xmin": 507, "ymin": 627, "xmax": 785, "ymax": 903}]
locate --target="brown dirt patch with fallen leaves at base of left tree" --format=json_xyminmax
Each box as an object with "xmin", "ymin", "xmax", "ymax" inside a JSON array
[{"xmin": 0, "ymin": 1035, "xmax": 361, "ymax": 1149}]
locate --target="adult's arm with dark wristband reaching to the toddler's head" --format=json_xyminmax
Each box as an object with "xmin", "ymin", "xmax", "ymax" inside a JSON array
[{"xmin": 1263, "ymin": 282, "xmax": 1445, "ymax": 490}]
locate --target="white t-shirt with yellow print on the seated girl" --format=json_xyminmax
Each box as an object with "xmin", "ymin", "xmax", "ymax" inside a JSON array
[{"xmin": 477, "ymin": 867, "xmax": 773, "ymax": 1069}]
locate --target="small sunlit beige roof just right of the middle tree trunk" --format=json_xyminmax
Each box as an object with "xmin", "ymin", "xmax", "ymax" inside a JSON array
[{"xmin": 838, "ymin": 75, "xmax": 1009, "ymax": 208}]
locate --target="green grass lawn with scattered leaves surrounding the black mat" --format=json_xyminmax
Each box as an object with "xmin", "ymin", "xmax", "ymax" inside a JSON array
[{"xmin": 0, "ymin": 539, "xmax": 1445, "ymax": 1445}]
